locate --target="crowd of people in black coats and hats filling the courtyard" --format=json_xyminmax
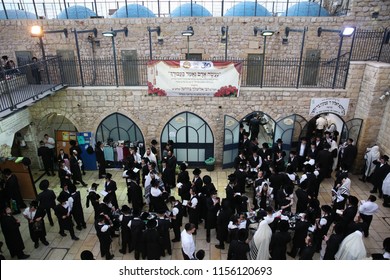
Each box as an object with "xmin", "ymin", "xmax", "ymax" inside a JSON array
[{"xmin": 1, "ymin": 124, "xmax": 390, "ymax": 260}]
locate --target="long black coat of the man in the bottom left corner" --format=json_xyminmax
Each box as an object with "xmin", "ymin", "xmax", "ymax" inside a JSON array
[{"xmin": 1, "ymin": 215, "xmax": 24, "ymax": 257}]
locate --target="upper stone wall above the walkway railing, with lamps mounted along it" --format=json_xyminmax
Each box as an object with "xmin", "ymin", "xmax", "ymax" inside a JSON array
[{"xmin": 0, "ymin": 0, "xmax": 390, "ymax": 63}]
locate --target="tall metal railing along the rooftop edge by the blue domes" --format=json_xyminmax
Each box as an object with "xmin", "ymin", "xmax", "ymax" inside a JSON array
[{"xmin": 2, "ymin": 0, "xmax": 340, "ymax": 19}]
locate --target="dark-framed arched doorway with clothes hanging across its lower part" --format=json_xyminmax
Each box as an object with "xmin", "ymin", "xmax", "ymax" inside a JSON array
[{"xmin": 96, "ymin": 113, "xmax": 145, "ymax": 155}]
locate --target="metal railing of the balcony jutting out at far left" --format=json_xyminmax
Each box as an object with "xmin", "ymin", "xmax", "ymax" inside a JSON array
[{"xmin": 0, "ymin": 58, "xmax": 62, "ymax": 112}]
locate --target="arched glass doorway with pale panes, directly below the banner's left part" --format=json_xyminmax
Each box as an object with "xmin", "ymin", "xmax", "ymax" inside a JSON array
[{"xmin": 160, "ymin": 112, "xmax": 214, "ymax": 166}]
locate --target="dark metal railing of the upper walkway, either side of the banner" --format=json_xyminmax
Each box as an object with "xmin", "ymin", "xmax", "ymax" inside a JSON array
[{"xmin": 55, "ymin": 57, "xmax": 348, "ymax": 88}]
